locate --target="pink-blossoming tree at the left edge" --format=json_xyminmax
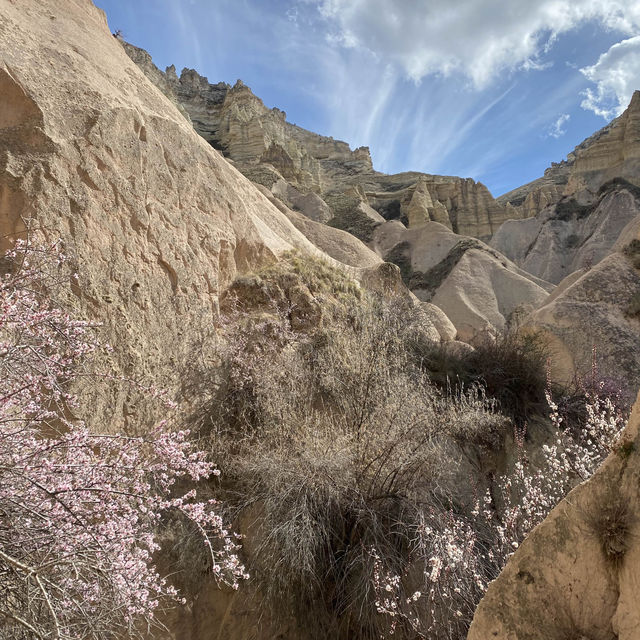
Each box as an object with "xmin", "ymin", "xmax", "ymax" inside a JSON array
[{"xmin": 0, "ymin": 242, "xmax": 246, "ymax": 640}]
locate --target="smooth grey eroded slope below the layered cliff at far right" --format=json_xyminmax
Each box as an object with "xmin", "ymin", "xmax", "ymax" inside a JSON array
[{"xmin": 490, "ymin": 179, "xmax": 640, "ymax": 283}]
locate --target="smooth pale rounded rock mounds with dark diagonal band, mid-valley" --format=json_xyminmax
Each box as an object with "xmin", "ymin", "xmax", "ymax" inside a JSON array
[{"xmin": 373, "ymin": 222, "xmax": 553, "ymax": 342}]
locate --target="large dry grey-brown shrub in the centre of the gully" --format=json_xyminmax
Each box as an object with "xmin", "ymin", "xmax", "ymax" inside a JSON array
[{"xmin": 201, "ymin": 284, "xmax": 505, "ymax": 638}]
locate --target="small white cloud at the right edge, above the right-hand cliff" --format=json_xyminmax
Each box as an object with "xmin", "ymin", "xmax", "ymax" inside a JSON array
[{"xmin": 580, "ymin": 36, "xmax": 640, "ymax": 120}]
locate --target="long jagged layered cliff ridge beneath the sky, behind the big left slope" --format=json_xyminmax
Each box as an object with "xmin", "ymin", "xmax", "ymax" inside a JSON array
[{"xmin": 122, "ymin": 42, "xmax": 523, "ymax": 242}]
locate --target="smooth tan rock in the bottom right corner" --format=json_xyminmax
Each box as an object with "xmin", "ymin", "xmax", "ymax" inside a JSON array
[{"xmin": 468, "ymin": 396, "xmax": 640, "ymax": 640}]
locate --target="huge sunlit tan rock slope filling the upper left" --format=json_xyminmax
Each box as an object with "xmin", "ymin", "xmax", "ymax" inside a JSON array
[{"xmin": 0, "ymin": 0, "xmax": 379, "ymax": 436}]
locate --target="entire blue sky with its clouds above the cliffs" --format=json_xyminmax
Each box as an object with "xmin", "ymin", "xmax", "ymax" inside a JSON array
[{"xmin": 95, "ymin": 0, "xmax": 640, "ymax": 195}]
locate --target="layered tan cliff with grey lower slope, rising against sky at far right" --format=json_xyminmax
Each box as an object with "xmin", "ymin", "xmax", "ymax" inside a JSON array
[{"xmin": 491, "ymin": 91, "xmax": 640, "ymax": 283}]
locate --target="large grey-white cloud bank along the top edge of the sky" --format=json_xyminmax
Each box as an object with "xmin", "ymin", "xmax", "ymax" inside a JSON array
[{"xmin": 306, "ymin": 0, "xmax": 640, "ymax": 88}]
